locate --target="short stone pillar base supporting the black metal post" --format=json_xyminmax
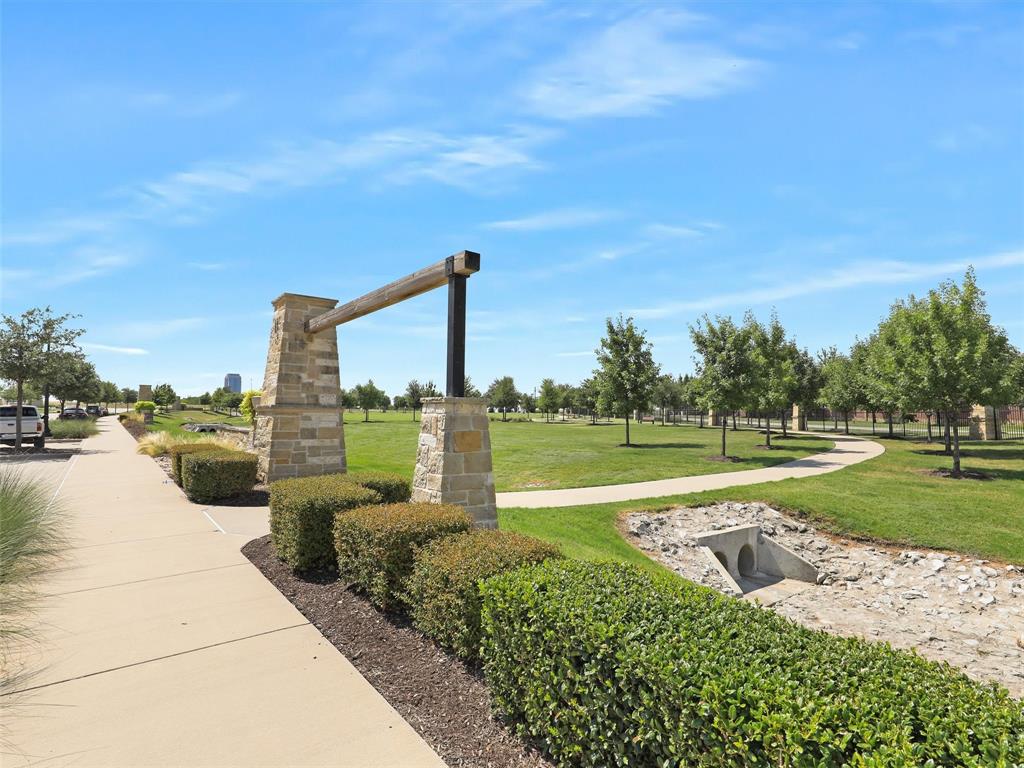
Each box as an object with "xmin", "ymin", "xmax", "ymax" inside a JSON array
[{"xmin": 413, "ymin": 397, "xmax": 498, "ymax": 528}]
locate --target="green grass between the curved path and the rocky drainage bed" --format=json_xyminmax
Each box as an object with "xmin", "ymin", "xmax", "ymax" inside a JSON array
[{"xmin": 499, "ymin": 440, "xmax": 1024, "ymax": 563}]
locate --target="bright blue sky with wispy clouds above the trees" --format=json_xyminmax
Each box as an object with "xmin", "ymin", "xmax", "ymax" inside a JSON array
[{"xmin": 0, "ymin": 2, "xmax": 1024, "ymax": 393}]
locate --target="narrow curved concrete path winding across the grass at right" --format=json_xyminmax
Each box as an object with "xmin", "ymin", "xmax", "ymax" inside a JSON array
[{"xmin": 498, "ymin": 433, "xmax": 885, "ymax": 509}]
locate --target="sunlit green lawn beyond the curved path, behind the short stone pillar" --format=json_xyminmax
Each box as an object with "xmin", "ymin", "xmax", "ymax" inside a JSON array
[{"xmin": 345, "ymin": 411, "xmax": 834, "ymax": 492}]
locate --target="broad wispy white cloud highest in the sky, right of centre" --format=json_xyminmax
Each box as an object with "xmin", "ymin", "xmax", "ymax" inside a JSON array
[{"xmin": 523, "ymin": 10, "xmax": 755, "ymax": 120}]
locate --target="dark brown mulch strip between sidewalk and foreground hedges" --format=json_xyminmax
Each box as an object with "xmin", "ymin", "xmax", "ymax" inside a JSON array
[{"xmin": 242, "ymin": 536, "xmax": 551, "ymax": 768}]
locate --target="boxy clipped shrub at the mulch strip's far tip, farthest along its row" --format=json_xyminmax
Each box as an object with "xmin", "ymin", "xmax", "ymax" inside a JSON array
[{"xmin": 270, "ymin": 474, "xmax": 381, "ymax": 570}]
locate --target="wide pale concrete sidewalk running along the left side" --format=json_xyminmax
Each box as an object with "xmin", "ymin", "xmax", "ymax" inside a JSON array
[{"xmin": 0, "ymin": 418, "xmax": 443, "ymax": 768}]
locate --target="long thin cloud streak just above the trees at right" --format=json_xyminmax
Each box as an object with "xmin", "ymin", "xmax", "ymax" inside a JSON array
[{"xmin": 629, "ymin": 250, "xmax": 1024, "ymax": 318}]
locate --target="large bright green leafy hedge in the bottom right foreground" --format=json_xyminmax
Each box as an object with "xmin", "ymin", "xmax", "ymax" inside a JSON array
[{"xmin": 481, "ymin": 561, "xmax": 1024, "ymax": 766}]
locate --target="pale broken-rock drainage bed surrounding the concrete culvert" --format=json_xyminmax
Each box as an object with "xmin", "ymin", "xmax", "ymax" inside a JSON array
[{"xmin": 625, "ymin": 503, "xmax": 1024, "ymax": 696}]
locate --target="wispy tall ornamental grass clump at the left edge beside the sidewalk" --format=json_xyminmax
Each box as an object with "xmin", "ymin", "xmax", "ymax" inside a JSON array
[{"xmin": 0, "ymin": 467, "xmax": 67, "ymax": 689}]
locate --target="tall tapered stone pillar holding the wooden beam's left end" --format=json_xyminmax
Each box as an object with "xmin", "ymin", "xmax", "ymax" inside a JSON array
[{"xmin": 253, "ymin": 293, "xmax": 345, "ymax": 482}]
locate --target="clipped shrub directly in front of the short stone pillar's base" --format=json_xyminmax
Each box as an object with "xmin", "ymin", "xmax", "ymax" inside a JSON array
[{"xmin": 334, "ymin": 503, "xmax": 472, "ymax": 610}]
